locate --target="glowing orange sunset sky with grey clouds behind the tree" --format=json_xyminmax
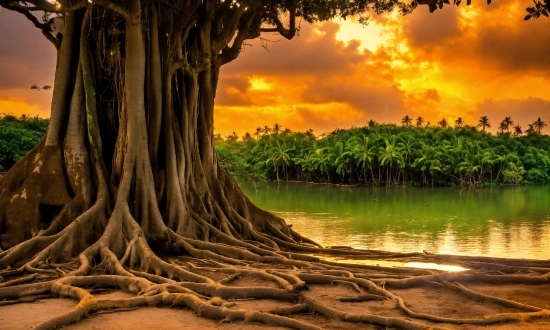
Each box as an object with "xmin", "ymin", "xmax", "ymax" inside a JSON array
[{"xmin": 0, "ymin": 0, "xmax": 550, "ymax": 136}]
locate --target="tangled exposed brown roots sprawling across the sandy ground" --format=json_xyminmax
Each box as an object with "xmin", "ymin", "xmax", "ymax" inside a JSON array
[{"xmin": 0, "ymin": 231, "xmax": 550, "ymax": 329}]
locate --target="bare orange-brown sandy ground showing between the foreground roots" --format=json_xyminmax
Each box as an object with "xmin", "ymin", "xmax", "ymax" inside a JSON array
[{"xmin": 0, "ymin": 283, "xmax": 550, "ymax": 330}]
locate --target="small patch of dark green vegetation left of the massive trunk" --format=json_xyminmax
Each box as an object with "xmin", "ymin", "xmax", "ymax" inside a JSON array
[{"xmin": 0, "ymin": 114, "xmax": 49, "ymax": 172}]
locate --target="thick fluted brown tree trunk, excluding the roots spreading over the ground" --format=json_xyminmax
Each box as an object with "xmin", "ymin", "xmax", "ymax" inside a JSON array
[{"xmin": 0, "ymin": 0, "xmax": 310, "ymax": 255}]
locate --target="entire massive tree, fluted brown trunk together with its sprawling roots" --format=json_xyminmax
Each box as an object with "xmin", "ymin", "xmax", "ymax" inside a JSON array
[{"xmin": 0, "ymin": 0, "xmax": 550, "ymax": 329}]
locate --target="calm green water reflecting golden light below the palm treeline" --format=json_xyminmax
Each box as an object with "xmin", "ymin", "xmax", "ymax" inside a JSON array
[{"xmin": 241, "ymin": 183, "xmax": 550, "ymax": 259}]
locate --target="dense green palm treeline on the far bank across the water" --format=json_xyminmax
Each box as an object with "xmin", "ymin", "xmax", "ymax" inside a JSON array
[{"xmin": 215, "ymin": 119, "xmax": 550, "ymax": 186}]
